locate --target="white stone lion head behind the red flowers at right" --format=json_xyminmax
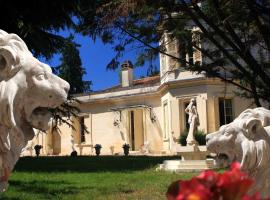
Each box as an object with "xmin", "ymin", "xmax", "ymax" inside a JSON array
[{"xmin": 206, "ymin": 107, "xmax": 270, "ymax": 198}]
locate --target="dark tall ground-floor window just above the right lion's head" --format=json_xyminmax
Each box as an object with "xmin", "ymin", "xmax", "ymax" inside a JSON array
[{"xmin": 219, "ymin": 98, "xmax": 233, "ymax": 126}]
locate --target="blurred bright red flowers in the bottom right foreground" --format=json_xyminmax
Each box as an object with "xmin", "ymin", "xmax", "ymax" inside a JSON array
[{"xmin": 166, "ymin": 163, "xmax": 260, "ymax": 200}]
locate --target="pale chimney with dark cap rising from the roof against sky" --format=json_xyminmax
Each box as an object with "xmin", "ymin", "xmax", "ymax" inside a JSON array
[{"xmin": 121, "ymin": 60, "xmax": 133, "ymax": 87}]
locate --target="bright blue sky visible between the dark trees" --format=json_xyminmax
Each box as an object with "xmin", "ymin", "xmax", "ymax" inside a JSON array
[{"xmin": 45, "ymin": 31, "xmax": 159, "ymax": 91}]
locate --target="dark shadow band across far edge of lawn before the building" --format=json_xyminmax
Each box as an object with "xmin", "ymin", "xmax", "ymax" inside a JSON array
[{"xmin": 15, "ymin": 156, "xmax": 180, "ymax": 172}]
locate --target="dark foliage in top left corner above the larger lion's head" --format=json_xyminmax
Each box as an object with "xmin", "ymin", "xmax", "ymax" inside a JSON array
[{"xmin": 0, "ymin": 0, "xmax": 90, "ymax": 59}]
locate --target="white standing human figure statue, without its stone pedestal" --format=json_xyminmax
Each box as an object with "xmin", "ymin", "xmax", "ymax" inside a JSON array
[{"xmin": 185, "ymin": 98, "xmax": 199, "ymax": 145}]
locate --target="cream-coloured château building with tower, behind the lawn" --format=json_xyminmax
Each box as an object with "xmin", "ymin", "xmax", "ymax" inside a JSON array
[{"xmin": 22, "ymin": 34, "xmax": 252, "ymax": 155}]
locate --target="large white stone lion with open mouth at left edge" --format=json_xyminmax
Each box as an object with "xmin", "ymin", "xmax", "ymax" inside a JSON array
[{"xmin": 0, "ymin": 30, "xmax": 69, "ymax": 192}]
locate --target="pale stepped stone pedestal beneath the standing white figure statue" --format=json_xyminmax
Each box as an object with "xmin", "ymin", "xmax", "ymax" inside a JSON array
[{"xmin": 157, "ymin": 145, "xmax": 217, "ymax": 172}]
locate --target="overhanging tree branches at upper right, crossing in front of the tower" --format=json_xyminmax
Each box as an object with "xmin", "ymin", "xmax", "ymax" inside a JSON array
[{"xmin": 77, "ymin": 0, "xmax": 270, "ymax": 106}]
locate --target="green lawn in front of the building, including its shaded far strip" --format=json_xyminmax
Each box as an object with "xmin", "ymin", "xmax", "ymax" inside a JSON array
[{"xmin": 0, "ymin": 156, "xmax": 198, "ymax": 200}]
